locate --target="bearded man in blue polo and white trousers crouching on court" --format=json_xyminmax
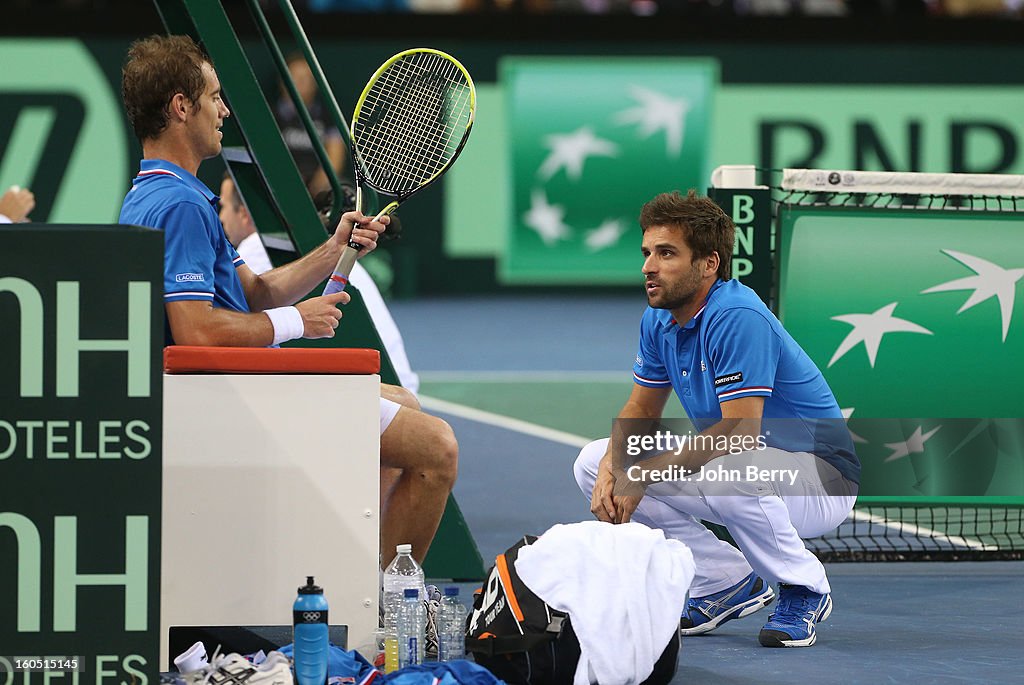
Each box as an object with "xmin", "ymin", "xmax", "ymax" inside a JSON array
[{"xmin": 574, "ymin": 190, "xmax": 860, "ymax": 647}]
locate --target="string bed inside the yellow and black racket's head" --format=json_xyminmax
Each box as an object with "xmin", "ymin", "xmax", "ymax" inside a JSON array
[{"xmin": 353, "ymin": 53, "xmax": 473, "ymax": 195}]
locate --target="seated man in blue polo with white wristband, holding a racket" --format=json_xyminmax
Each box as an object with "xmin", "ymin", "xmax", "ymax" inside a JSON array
[{"xmin": 120, "ymin": 36, "xmax": 458, "ymax": 565}]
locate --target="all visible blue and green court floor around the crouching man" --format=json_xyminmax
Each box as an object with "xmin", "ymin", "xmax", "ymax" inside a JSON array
[{"xmin": 392, "ymin": 293, "xmax": 1024, "ymax": 685}]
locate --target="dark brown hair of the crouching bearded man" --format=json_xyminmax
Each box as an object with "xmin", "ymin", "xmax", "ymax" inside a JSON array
[{"xmin": 640, "ymin": 188, "xmax": 736, "ymax": 281}]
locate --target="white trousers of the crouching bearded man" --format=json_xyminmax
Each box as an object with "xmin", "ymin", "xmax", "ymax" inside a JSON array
[{"xmin": 573, "ymin": 438, "xmax": 856, "ymax": 597}]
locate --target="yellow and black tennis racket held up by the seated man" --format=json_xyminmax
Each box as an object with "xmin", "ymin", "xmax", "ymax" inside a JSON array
[{"xmin": 324, "ymin": 48, "xmax": 476, "ymax": 295}]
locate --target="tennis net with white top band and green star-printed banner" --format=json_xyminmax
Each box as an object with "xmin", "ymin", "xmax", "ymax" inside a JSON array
[{"xmin": 713, "ymin": 165, "xmax": 1024, "ymax": 561}]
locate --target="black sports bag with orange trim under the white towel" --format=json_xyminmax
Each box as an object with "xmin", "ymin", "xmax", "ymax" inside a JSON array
[{"xmin": 466, "ymin": 536, "xmax": 679, "ymax": 685}]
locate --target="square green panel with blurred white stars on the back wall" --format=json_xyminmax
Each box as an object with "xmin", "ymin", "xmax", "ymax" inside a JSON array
[{"xmin": 503, "ymin": 58, "xmax": 716, "ymax": 283}]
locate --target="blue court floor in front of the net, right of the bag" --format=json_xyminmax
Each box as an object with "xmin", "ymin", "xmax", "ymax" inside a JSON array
[{"xmin": 673, "ymin": 561, "xmax": 1024, "ymax": 685}]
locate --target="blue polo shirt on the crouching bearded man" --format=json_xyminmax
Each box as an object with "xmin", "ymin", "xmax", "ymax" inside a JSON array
[{"xmin": 633, "ymin": 281, "xmax": 860, "ymax": 482}]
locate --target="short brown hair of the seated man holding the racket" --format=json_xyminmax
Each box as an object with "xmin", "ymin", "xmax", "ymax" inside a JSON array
[{"xmin": 121, "ymin": 36, "xmax": 213, "ymax": 141}]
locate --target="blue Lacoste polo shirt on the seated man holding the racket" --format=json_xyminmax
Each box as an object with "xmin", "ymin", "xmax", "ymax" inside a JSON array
[{"xmin": 118, "ymin": 160, "xmax": 249, "ymax": 343}]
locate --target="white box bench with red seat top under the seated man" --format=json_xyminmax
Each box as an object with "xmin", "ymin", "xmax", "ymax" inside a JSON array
[{"xmin": 160, "ymin": 347, "xmax": 380, "ymax": 670}]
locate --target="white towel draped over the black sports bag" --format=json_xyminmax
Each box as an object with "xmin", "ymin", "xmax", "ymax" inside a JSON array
[{"xmin": 515, "ymin": 521, "xmax": 694, "ymax": 685}]
